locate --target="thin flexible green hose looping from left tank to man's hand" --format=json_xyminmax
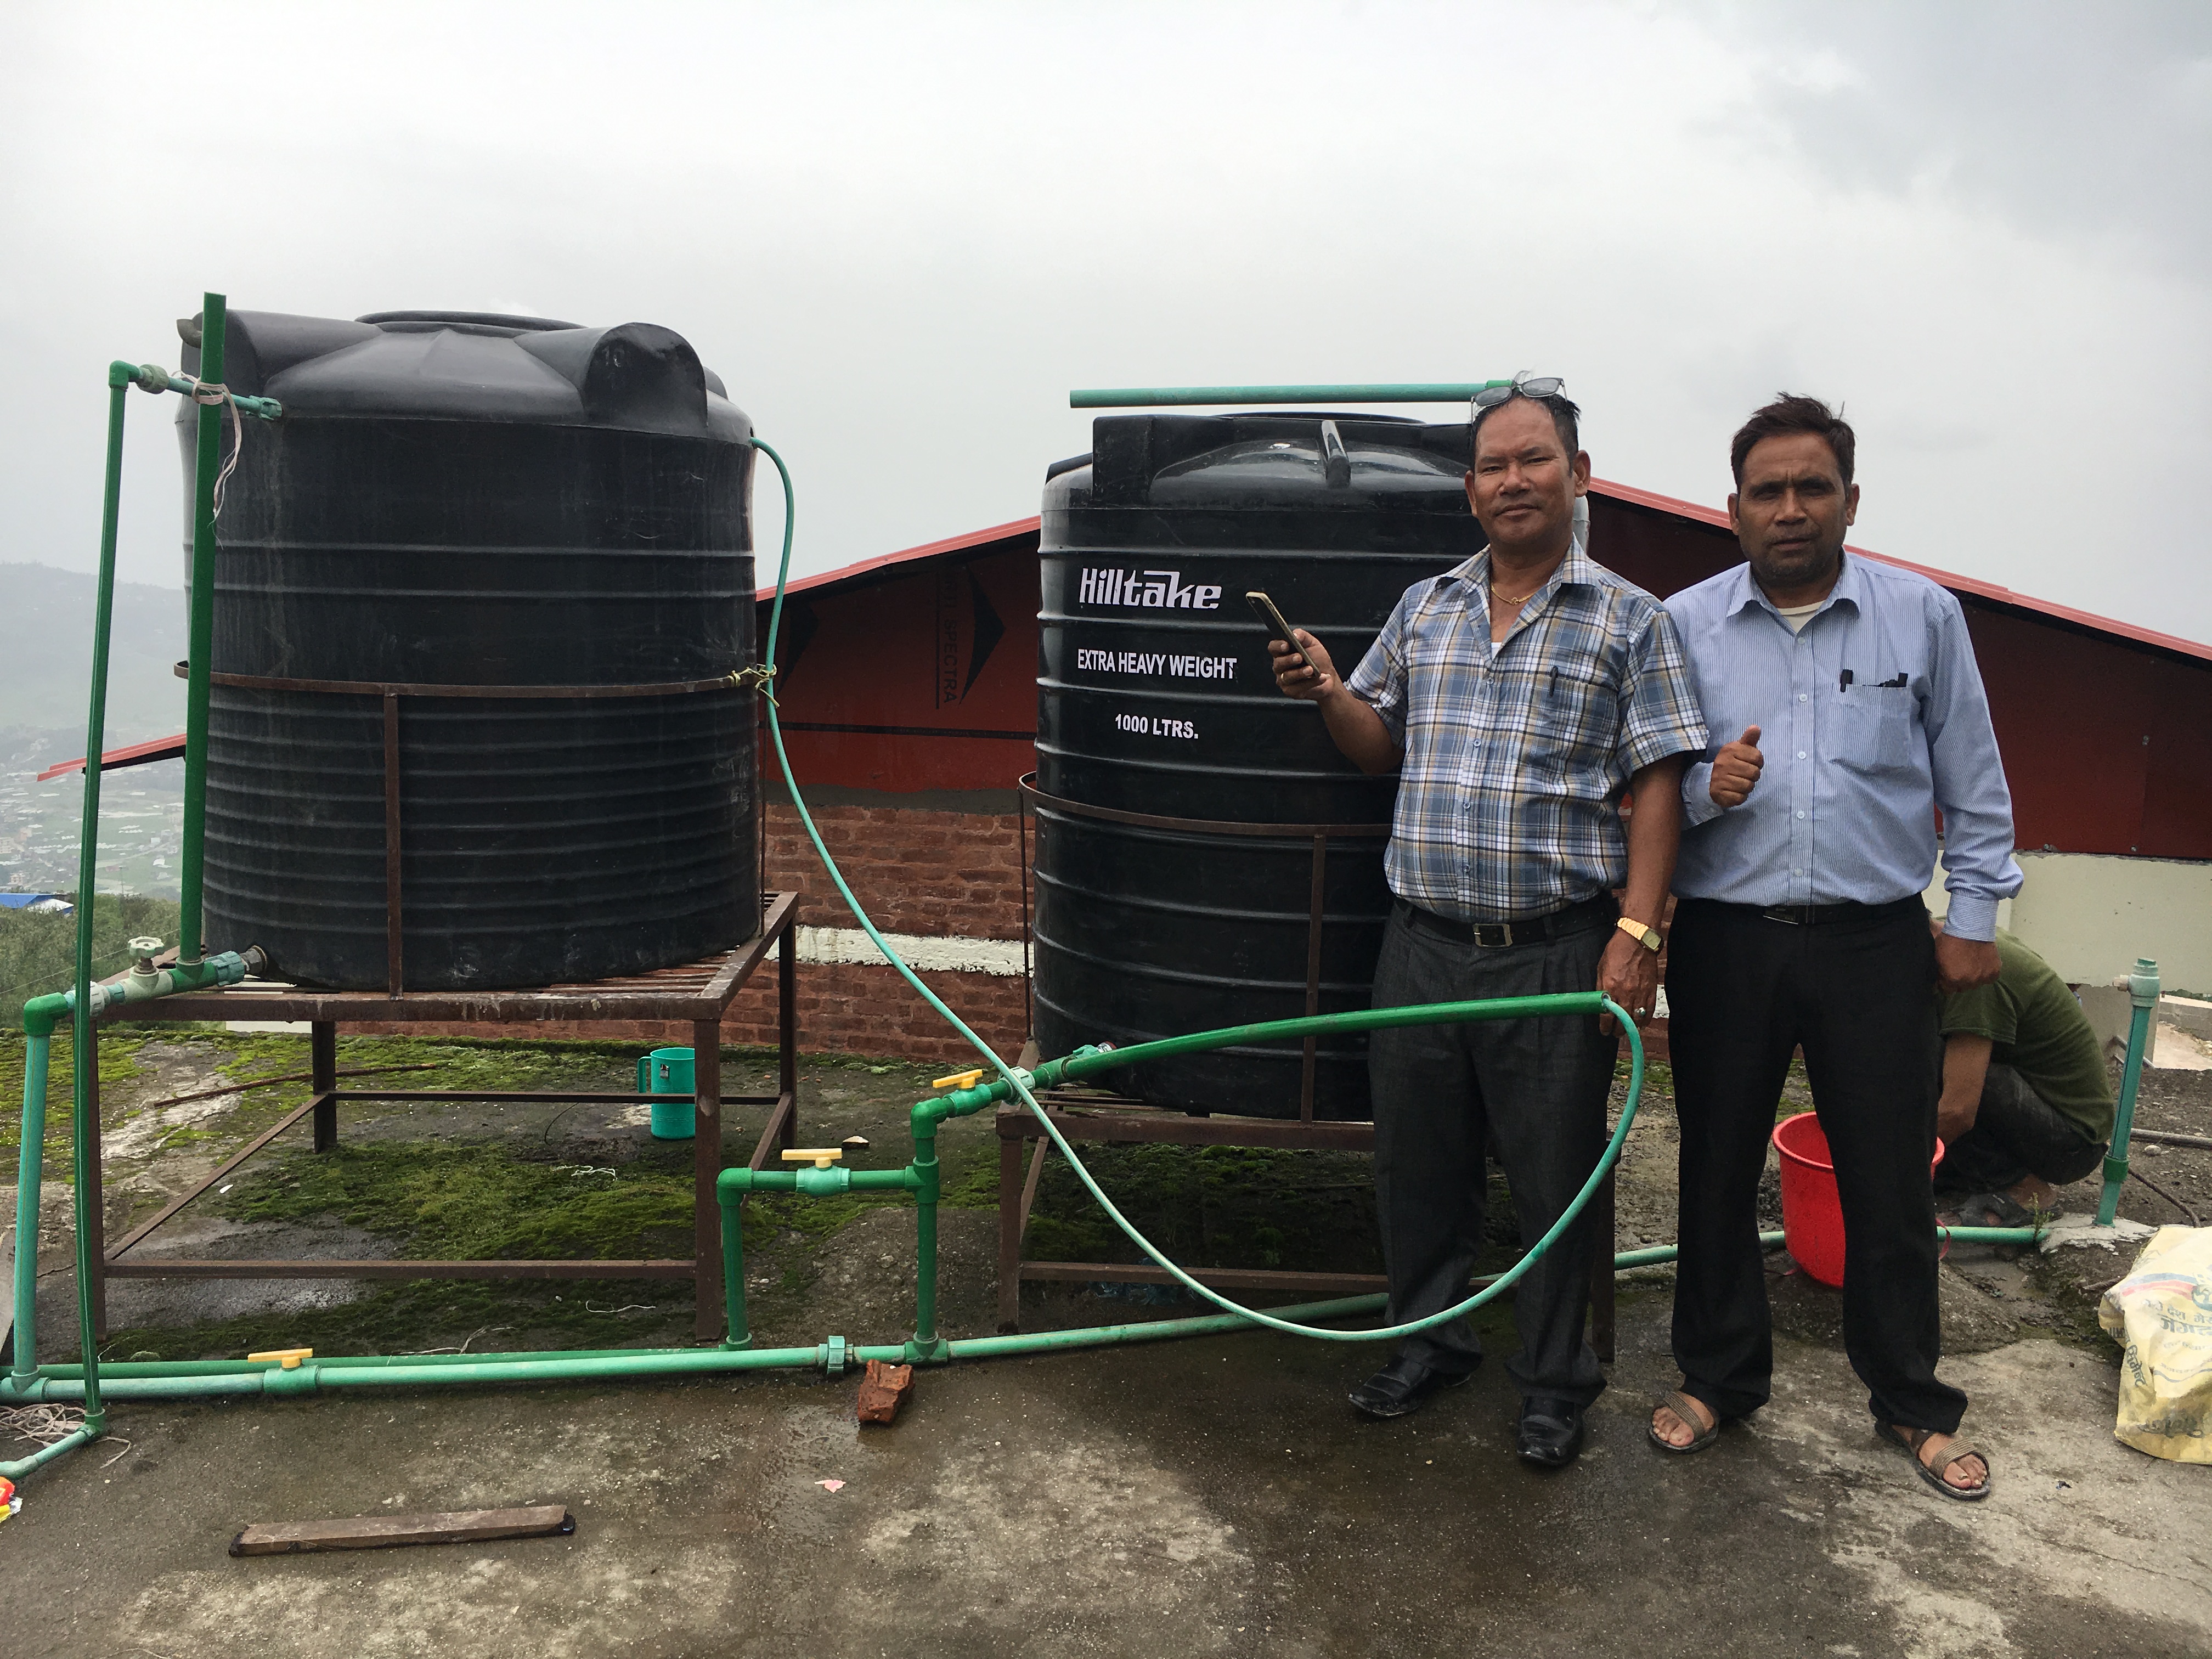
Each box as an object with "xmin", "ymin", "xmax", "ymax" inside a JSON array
[{"xmin": 752, "ymin": 438, "xmax": 1644, "ymax": 1342}]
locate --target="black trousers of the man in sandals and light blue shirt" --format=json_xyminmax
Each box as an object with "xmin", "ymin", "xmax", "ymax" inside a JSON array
[{"xmin": 1668, "ymin": 898, "xmax": 1966, "ymax": 1434}]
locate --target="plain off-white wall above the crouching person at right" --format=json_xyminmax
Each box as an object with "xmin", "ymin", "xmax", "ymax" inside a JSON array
[{"xmin": 1927, "ymin": 851, "xmax": 2212, "ymax": 993}]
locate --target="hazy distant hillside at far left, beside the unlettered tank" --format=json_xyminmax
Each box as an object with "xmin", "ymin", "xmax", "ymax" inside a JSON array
[{"xmin": 0, "ymin": 564, "xmax": 184, "ymax": 748}]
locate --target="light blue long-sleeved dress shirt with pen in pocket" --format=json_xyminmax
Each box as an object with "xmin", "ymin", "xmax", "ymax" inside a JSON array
[{"xmin": 1666, "ymin": 553, "xmax": 2022, "ymax": 940}]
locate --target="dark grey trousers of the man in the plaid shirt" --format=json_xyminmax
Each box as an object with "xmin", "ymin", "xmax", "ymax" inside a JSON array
[{"xmin": 1367, "ymin": 902, "xmax": 1619, "ymax": 1404}]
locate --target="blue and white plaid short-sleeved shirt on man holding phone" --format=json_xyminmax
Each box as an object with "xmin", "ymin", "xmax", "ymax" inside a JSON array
[{"xmin": 1347, "ymin": 553, "xmax": 1706, "ymax": 922}]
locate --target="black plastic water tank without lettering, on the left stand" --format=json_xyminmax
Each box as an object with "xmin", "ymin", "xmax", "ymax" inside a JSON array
[{"xmin": 179, "ymin": 312, "xmax": 761, "ymax": 989}]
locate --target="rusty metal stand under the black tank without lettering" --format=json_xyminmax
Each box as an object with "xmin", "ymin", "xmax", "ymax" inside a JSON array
[{"xmin": 82, "ymin": 894, "xmax": 799, "ymax": 1338}]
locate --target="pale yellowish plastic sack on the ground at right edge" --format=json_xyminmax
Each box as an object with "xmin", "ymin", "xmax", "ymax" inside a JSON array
[{"xmin": 2097, "ymin": 1228, "xmax": 2212, "ymax": 1462}]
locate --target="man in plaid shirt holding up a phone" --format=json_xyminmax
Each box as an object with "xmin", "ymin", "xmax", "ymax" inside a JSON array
[{"xmin": 1269, "ymin": 387, "xmax": 1706, "ymax": 1466}]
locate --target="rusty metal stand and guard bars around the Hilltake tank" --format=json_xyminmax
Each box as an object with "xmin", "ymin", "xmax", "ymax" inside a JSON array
[{"xmin": 997, "ymin": 772, "xmax": 1615, "ymax": 1363}]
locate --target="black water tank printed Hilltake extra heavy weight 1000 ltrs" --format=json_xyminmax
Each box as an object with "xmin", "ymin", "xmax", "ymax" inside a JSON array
[{"xmin": 1035, "ymin": 414, "xmax": 1484, "ymax": 1119}]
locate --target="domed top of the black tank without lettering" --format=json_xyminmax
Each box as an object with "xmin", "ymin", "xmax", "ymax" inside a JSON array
[{"xmin": 184, "ymin": 312, "xmax": 752, "ymax": 442}]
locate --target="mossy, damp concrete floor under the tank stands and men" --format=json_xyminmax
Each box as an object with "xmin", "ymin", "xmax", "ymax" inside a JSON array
[{"xmin": 0, "ymin": 1031, "xmax": 2212, "ymax": 1659}]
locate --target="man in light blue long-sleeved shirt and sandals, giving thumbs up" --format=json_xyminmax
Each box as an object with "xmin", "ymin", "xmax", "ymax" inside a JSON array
[{"xmin": 1650, "ymin": 396, "xmax": 2022, "ymax": 1500}]
